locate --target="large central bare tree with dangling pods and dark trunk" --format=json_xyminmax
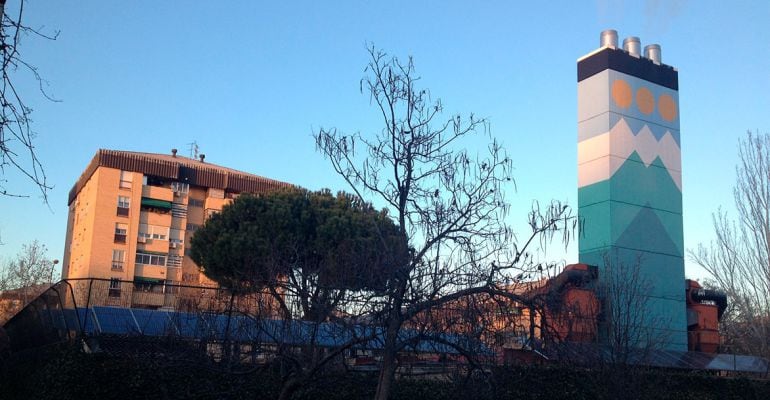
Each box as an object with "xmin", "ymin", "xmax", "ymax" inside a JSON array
[{"xmin": 315, "ymin": 47, "xmax": 574, "ymax": 400}]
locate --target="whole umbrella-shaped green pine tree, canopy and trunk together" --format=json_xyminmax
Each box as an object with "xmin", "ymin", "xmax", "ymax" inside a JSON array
[{"xmin": 191, "ymin": 188, "xmax": 409, "ymax": 399}]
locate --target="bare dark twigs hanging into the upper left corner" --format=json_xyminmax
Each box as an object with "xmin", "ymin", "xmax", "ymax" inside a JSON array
[{"xmin": 0, "ymin": 0, "xmax": 58, "ymax": 202}]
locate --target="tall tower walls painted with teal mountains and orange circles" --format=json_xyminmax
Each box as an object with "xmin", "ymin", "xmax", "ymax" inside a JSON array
[{"xmin": 578, "ymin": 49, "xmax": 687, "ymax": 350}]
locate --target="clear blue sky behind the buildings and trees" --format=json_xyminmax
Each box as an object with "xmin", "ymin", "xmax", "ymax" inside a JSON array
[{"xmin": 0, "ymin": 0, "xmax": 770, "ymax": 277}]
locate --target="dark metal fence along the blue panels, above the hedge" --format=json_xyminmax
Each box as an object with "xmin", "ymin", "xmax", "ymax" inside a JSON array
[{"xmin": 0, "ymin": 278, "xmax": 769, "ymax": 376}]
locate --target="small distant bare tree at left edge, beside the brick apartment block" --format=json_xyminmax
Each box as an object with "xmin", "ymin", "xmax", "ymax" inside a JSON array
[{"xmin": 0, "ymin": 241, "xmax": 58, "ymax": 322}]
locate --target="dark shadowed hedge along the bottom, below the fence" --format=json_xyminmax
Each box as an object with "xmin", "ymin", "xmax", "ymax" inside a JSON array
[{"xmin": 0, "ymin": 347, "xmax": 770, "ymax": 400}]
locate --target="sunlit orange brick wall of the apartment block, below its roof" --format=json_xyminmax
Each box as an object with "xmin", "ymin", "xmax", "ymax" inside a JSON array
[{"xmin": 62, "ymin": 166, "xmax": 232, "ymax": 306}]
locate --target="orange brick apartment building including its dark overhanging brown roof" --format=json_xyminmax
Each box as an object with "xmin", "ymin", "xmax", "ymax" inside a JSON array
[{"xmin": 62, "ymin": 149, "xmax": 289, "ymax": 308}]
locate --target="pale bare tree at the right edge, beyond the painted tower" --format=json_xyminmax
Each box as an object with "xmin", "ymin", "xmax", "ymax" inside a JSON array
[{"xmin": 690, "ymin": 132, "xmax": 770, "ymax": 357}]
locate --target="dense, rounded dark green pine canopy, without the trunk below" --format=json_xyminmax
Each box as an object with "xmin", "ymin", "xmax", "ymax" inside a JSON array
[{"xmin": 190, "ymin": 188, "xmax": 408, "ymax": 295}]
